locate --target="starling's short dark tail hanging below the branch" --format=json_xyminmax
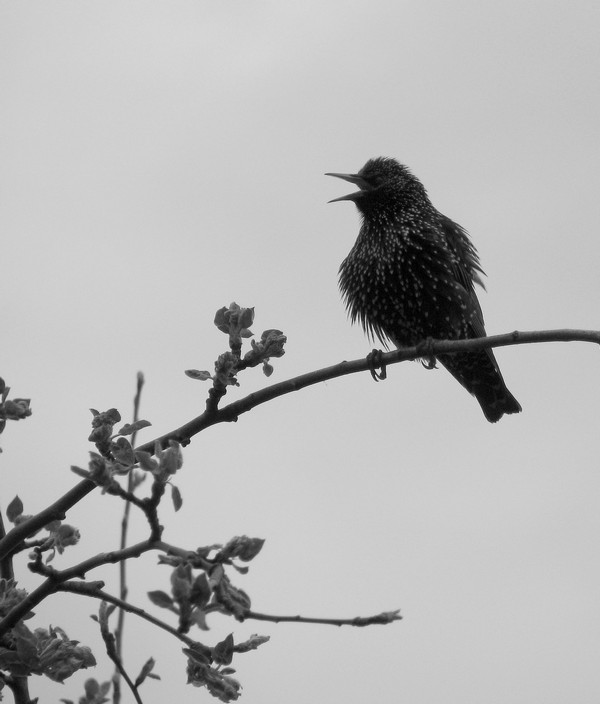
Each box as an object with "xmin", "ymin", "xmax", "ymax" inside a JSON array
[{"xmin": 438, "ymin": 350, "xmax": 521, "ymax": 423}]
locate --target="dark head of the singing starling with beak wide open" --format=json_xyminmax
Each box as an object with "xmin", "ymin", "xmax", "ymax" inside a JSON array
[{"xmin": 325, "ymin": 156, "xmax": 425, "ymax": 213}]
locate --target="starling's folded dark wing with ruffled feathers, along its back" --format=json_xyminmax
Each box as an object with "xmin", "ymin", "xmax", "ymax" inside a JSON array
[{"xmin": 440, "ymin": 213, "xmax": 485, "ymax": 337}]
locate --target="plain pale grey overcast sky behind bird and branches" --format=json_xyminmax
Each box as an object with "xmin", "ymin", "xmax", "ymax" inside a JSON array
[{"xmin": 0, "ymin": 0, "xmax": 600, "ymax": 704}]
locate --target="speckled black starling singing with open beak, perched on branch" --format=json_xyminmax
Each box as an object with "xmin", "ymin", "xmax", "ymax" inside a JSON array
[{"xmin": 326, "ymin": 157, "xmax": 521, "ymax": 423}]
